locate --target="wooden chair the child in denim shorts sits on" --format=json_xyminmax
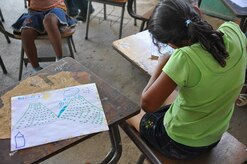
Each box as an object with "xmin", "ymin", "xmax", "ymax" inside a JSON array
[{"xmin": 0, "ymin": 26, "xmax": 76, "ymax": 80}]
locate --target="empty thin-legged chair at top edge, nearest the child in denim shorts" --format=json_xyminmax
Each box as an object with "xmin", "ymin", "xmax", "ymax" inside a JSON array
[{"xmin": 85, "ymin": 0, "xmax": 128, "ymax": 40}]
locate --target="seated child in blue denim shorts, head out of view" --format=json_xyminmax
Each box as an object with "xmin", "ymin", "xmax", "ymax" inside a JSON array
[{"xmin": 12, "ymin": 0, "xmax": 76, "ymax": 71}]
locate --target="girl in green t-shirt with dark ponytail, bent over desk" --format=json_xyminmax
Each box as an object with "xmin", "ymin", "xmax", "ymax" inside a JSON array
[{"xmin": 128, "ymin": 0, "xmax": 247, "ymax": 159}]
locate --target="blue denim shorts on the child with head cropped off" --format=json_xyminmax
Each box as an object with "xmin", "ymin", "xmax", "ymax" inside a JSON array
[{"xmin": 12, "ymin": 8, "xmax": 76, "ymax": 34}]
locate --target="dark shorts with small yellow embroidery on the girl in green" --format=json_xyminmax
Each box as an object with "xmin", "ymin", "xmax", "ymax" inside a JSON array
[{"xmin": 140, "ymin": 106, "xmax": 219, "ymax": 159}]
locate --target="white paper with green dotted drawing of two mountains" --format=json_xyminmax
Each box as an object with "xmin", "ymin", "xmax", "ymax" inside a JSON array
[{"xmin": 11, "ymin": 83, "xmax": 109, "ymax": 151}]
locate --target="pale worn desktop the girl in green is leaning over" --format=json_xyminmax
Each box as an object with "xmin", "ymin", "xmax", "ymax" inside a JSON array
[{"xmin": 112, "ymin": 30, "xmax": 158, "ymax": 75}]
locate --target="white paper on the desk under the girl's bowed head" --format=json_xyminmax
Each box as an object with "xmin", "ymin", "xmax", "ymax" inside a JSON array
[{"xmin": 136, "ymin": 30, "xmax": 174, "ymax": 56}]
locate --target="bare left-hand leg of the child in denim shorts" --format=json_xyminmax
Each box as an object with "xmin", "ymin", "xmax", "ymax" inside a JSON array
[{"xmin": 21, "ymin": 28, "xmax": 39, "ymax": 68}]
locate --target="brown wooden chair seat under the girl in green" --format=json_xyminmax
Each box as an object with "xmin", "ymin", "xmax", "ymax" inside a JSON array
[{"xmin": 120, "ymin": 122, "xmax": 247, "ymax": 164}]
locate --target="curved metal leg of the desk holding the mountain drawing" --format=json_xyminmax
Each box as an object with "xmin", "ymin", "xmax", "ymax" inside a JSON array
[{"xmin": 101, "ymin": 124, "xmax": 122, "ymax": 164}]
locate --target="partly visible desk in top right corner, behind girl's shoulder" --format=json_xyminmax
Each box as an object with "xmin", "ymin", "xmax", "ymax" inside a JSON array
[{"xmin": 222, "ymin": 0, "xmax": 247, "ymax": 32}]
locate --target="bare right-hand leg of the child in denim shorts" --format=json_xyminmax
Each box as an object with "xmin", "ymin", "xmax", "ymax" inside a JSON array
[{"xmin": 43, "ymin": 14, "xmax": 63, "ymax": 58}]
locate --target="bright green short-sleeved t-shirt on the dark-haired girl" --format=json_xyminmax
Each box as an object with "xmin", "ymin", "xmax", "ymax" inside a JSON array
[{"xmin": 163, "ymin": 22, "xmax": 247, "ymax": 147}]
